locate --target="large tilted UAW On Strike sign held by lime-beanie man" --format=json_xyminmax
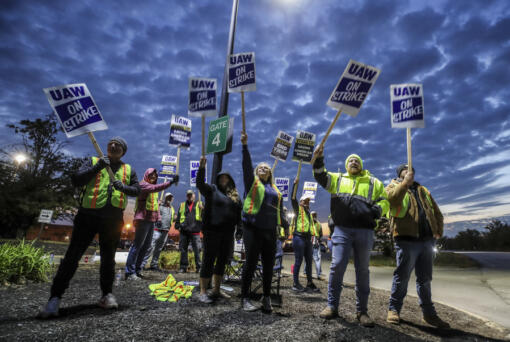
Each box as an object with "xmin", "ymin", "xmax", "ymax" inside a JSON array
[{"xmin": 327, "ymin": 59, "xmax": 381, "ymax": 117}]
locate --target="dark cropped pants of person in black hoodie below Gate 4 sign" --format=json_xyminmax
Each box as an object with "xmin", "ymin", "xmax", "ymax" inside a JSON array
[{"xmin": 200, "ymin": 229, "xmax": 234, "ymax": 278}]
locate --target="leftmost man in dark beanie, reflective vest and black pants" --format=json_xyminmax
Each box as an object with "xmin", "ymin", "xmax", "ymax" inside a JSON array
[{"xmin": 39, "ymin": 137, "xmax": 140, "ymax": 318}]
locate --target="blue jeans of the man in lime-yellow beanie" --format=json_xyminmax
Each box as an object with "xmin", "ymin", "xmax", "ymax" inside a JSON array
[{"xmin": 328, "ymin": 226, "xmax": 374, "ymax": 313}]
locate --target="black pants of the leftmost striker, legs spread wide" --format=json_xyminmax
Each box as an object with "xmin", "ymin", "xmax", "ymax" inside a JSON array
[{"xmin": 51, "ymin": 213, "xmax": 124, "ymax": 298}]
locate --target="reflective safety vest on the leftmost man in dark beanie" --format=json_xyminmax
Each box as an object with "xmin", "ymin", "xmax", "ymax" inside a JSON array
[{"xmin": 80, "ymin": 157, "xmax": 131, "ymax": 209}]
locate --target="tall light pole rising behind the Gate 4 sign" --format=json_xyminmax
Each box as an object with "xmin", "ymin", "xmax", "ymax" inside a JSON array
[{"xmin": 211, "ymin": 0, "xmax": 239, "ymax": 183}]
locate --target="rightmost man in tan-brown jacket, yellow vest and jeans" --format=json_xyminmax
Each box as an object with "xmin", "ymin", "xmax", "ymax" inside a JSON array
[{"xmin": 386, "ymin": 164, "xmax": 450, "ymax": 329}]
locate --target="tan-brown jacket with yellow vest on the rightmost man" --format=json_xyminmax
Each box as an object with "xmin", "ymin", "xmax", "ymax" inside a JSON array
[{"xmin": 386, "ymin": 179, "xmax": 443, "ymax": 238}]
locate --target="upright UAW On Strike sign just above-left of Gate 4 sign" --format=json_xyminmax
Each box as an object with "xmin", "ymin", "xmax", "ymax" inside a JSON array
[{"xmin": 188, "ymin": 77, "xmax": 217, "ymax": 117}]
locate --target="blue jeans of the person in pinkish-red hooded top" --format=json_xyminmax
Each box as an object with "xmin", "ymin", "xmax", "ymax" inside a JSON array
[{"xmin": 126, "ymin": 220, "xmax": 154, "ymax": 276}]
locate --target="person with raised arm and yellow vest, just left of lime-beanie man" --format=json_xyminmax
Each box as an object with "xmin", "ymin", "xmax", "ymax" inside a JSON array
[{"xmin": 291, "ymin": 178, "xmax": 319, "ymax": 292}]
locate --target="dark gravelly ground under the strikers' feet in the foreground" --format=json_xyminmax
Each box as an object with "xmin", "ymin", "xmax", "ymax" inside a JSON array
[{"xmin": 0, "ymin": 265, "xmax": 509, "ymax": 342}]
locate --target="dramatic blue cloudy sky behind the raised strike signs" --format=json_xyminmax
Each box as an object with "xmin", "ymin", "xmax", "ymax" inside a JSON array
[{"xmin": 0, "ymin": 0, "xmax": 510, "ymax": 227}]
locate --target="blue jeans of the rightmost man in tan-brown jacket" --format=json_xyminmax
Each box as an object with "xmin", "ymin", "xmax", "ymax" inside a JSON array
[{"xmin": 389, "ymin": 239, "xmax": 436, "ymax": 315}]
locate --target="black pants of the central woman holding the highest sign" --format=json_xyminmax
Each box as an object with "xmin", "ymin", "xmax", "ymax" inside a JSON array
[{"xmin": 241, "ymin": 226, "xmax": 276, "ymax": 298}]
